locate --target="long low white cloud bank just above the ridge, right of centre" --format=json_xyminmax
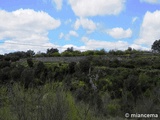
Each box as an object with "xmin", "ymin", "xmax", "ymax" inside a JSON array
[{"xmin": 82, "ymin": 37, "xmax": 128, "ymax": 50}]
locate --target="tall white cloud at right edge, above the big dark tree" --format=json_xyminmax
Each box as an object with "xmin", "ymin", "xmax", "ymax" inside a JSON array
[{"xmin": 135, "ymin": 10, "xmax": 160, "ymax": 47}]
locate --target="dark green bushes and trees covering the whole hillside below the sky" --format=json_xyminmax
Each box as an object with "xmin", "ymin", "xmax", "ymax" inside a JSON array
[{"xmin": 0, "ymin": 42, "xmax": 160, "ymax": 120}]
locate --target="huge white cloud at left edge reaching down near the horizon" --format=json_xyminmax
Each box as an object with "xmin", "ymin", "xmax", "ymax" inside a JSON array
[{"xmin": 0, "ymin": 9, "xmax": 61, "ymax": 52}]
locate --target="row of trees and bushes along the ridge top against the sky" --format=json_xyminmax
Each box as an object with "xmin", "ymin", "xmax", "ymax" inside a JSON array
[{"xmin": 0, "ymin": 47, "xmax": 152, "ymax": 62}]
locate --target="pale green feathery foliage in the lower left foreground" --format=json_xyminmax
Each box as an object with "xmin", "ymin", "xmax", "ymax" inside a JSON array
[{"xmin": 0, "ymin": 83, "xmax": 111, "ymax": 120}]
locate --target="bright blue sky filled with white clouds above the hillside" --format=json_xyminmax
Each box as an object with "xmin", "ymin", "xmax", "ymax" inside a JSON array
[{"xmin": 0, "ymin": 0, "xmax": 160, "ymax": 54}]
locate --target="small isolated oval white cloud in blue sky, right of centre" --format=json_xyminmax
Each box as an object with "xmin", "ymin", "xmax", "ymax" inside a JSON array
[{"xmin": 107, "ymin": 27, "xmax": 132, "ymax": 39}]
